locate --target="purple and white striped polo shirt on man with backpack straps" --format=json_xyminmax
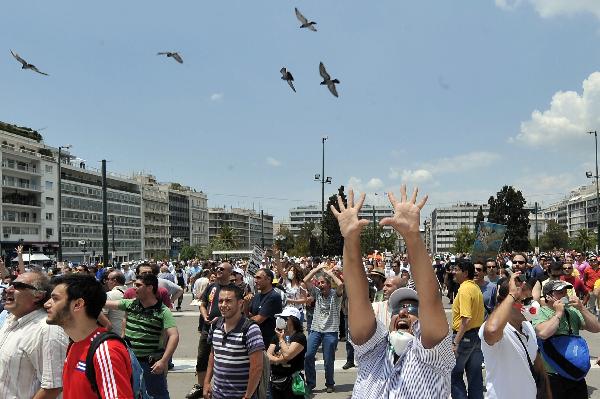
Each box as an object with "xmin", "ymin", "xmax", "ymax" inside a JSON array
[{"xmin": 209, "ymin": 317, "xmax": 265, "ymax": 399}]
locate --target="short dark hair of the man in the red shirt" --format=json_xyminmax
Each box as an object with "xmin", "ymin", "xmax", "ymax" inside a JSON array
[{"xmin": 52, "ymin": 274, "xmax": 106, "ymax": 320}]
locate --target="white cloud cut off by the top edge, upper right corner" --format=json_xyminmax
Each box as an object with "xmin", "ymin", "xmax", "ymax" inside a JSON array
[{"xmin": 495, "ymin": 0, "xmax": 600, "ymax": 19}]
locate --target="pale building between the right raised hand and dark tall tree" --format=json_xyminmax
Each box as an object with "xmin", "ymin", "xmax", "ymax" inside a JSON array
[{"xmin": 431, "ymin": 202, "xmax": 490, "ymax": 253}]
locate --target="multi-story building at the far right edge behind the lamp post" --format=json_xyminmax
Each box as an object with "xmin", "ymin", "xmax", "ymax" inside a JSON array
[{"xmin": 542, "ymin": 184, "xmax": 598, "ymax": 237}]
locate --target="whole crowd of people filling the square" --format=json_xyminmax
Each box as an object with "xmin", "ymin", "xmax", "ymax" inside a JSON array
[{"xmin": 0, "ymin": 187, "xmax": 600, "ymax": 399}]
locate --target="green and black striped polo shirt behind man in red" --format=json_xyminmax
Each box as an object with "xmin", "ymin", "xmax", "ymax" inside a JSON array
[{"xmin": 119, "ymin": 299, "xmax": 177, "ymax": 357}]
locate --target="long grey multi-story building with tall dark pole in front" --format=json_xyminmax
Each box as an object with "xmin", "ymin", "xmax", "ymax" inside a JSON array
[{"xmin": 61, "ymin": 161, "xmax": 142, "ymax": 262}]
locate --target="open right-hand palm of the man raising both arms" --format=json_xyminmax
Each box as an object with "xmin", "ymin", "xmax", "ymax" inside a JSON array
[{"xmin": 379, "ymin": 184, "xmax": 427, "ymax": 236}]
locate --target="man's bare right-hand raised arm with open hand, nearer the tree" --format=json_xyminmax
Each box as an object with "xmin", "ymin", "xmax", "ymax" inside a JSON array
[{"xmin": 380, "ymin": 184, "xmax": 448, "ymax": 349}]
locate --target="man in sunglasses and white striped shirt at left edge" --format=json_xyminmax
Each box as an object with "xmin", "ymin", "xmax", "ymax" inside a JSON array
[{"xmin": 0, "ymin": 272, "xmax": 69, "ymax": 398}]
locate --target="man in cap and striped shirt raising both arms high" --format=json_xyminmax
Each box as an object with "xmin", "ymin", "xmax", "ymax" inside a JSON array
[{"xmin": 331, "ymin": 185, "xmax": 455, "ymax": 399}]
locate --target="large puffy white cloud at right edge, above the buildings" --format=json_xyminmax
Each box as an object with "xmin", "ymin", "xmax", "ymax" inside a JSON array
[{"xmin": 509, "ymin": 72, "xmax": 600, "ymax": 146}]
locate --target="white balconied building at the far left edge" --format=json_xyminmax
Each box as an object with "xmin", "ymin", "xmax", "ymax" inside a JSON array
[{"xmin": 0, "ymin": 122, "xmax": 58, "ymax": 256}]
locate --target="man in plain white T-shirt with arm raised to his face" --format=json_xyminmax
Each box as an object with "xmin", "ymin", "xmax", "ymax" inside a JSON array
[{"xmin": 479, "ymin": 272, "xmax": 550, "ymax": 399}]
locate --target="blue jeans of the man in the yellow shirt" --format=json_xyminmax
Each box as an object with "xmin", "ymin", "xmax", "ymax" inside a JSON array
[{"xmin": 451, "ymin": 329, "xmax": 486, "ymax": 399}]
